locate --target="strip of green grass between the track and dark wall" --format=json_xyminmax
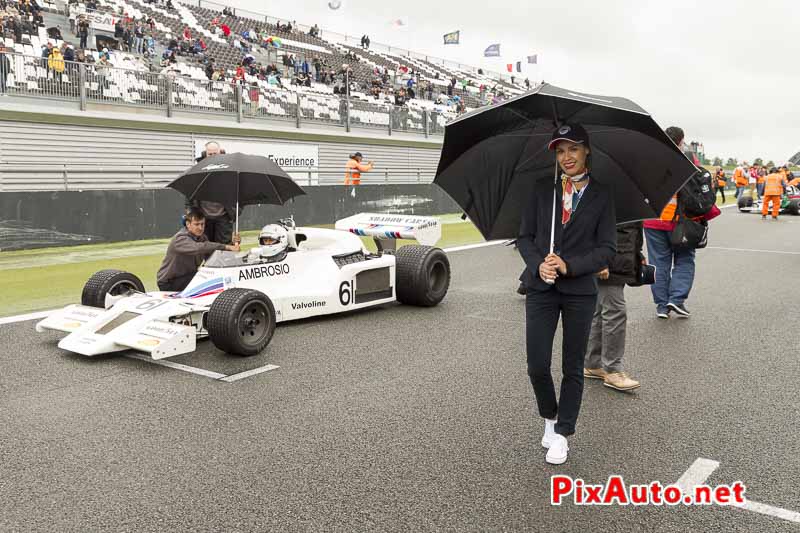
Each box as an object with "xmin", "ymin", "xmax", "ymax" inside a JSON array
[{"xmin": 0, "ymin": 217, "xmax": 483, "ymax": 316}]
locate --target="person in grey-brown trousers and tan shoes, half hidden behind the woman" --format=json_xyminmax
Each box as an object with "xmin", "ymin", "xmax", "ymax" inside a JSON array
[{"xmin": 583, "ymin": 222, "xmax": 645, "ymax": 391}]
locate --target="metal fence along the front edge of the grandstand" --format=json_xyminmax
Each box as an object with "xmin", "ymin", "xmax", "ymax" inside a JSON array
[{"xmin": 0, "ymin": 54, "xmax": 456, "ymax": 137}]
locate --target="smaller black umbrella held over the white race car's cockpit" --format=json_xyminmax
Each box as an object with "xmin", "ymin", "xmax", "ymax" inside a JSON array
[{"xmin": 167, "ymin": 152, "xmax": 305, "ymax": 232}]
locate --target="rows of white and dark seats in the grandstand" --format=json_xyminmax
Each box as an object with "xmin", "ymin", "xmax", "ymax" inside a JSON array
[{"xmin": 5, "ymin": 0, "xmax": 524, "ymax": 129}]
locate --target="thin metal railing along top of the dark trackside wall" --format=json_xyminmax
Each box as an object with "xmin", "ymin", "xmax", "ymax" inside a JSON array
[{"xmin": 0, "ymin": 164, "xmax": 436, "ymax": 192}]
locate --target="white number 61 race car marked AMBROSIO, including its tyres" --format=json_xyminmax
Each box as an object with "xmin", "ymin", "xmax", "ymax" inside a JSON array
[{"xmin": 36, "ymin": 213, "xmax": 450, "ymax": 359}]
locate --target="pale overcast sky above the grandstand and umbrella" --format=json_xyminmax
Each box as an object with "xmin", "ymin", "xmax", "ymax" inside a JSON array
[{"xmin": 233, "ymin": 0, "xmax": 800, "ymax": 163}]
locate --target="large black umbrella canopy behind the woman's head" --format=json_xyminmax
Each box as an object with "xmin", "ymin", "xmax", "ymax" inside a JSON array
[{"xmin": 434, "ymin": 84, "xmax": 697, "ymax": 240}]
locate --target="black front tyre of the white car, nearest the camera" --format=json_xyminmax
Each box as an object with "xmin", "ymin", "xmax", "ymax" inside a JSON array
[{"xmin": 206, "ymin": 289, "xmax": 275, "ymax": 356}]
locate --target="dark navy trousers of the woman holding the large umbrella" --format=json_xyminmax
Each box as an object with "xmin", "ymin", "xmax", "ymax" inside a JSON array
[{"xmin": 525, "ymin": 288, "xmax": 597, "ymax": 436}]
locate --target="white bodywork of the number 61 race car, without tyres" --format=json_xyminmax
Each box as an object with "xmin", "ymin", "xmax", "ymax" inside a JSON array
[{"xmin": 36, "ymin": 215, "xmax": 441, "ymax": 359}]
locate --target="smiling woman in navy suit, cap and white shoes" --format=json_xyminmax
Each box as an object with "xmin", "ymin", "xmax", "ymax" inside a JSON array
[{"xmin": 517, "ymin": 124, "xmax": 616, "ymax": 464}]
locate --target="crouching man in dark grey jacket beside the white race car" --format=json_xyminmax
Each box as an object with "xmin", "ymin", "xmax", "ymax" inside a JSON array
[{"xmin": 156, "ymin": 207, "xmax": 239, "ymax": 291}]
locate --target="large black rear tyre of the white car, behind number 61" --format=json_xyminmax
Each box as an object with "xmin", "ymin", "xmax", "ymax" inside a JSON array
[{"xmin": 395, "ymin": 244, "xmax": 450, "ymax": 307}]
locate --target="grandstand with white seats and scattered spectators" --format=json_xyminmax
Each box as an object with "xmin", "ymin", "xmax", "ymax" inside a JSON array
[{"xmin": 2, "ymin": 0, "xmax": 536, "ymax": 135}]
